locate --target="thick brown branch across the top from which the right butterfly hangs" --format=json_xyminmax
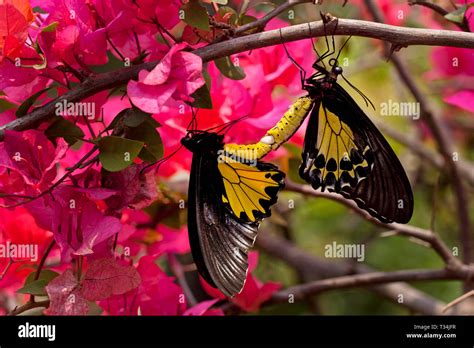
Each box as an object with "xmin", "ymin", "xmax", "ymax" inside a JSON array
[{"xmin": 0, "ymin": 19, "xmax": 474, "ymax": 141}]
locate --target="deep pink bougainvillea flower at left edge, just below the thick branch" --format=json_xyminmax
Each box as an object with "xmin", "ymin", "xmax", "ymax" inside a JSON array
[{"xmin": 0, "ymin": 130, "xmax": 67, "ymax": 192}]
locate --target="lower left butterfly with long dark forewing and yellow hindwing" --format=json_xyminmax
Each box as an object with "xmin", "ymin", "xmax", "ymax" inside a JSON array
[{"xmin": 181, "ymin": 131, "xmax": 285, "ymax": 296}]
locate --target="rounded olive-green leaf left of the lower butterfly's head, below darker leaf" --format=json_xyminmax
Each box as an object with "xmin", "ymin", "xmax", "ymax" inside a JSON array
[{"xmin": 99, "ymin": 136, "xmax": 144, "ymax": 172}]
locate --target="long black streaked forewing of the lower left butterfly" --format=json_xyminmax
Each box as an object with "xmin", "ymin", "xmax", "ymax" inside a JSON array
[{"xmin": 188, "ymin": 153, "xmax": 258, "ymax": 296}]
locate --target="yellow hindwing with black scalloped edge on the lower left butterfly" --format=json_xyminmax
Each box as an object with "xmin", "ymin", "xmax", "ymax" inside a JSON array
[{"xmin": 218, "ymin": 156, "xmax": 282, "ymax": 222}]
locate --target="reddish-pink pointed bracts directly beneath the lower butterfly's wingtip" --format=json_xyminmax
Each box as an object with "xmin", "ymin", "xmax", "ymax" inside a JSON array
[{"xmin": 201, "ymin": 251, "xmax": 281, "ymax": 312}]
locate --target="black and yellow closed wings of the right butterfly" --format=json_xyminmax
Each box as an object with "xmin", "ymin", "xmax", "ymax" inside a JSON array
[{"xmin": 300, "ymin": 83, "xmax": 413, "ymax": 223}]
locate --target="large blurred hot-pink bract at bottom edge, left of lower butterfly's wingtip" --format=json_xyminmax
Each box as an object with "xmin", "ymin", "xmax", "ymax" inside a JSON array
[{"xmin": 99, "ymin": 256, "xmax": 186, "ymax": 315}]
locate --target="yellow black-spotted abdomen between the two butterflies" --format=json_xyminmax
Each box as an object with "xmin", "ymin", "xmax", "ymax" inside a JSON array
[{"xmin": 224, "ymin": 96, "xmax": 314, "ymax": 160}]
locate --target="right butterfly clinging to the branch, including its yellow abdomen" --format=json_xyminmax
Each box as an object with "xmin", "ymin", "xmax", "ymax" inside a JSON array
[{"xmin": 226, "ymin": 17, "xmax": 413, "ymax": 223}]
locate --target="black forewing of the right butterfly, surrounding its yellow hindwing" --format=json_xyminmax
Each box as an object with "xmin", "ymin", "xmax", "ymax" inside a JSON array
[{"xmin": 300, "ymin": 83, "xmax": 413, "ymax": 223}]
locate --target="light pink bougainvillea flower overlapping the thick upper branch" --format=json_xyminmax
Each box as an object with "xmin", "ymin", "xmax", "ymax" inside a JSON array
[{"xmin": 127, "ymin": 44, "xmax": 205, "ymax": 113}]
